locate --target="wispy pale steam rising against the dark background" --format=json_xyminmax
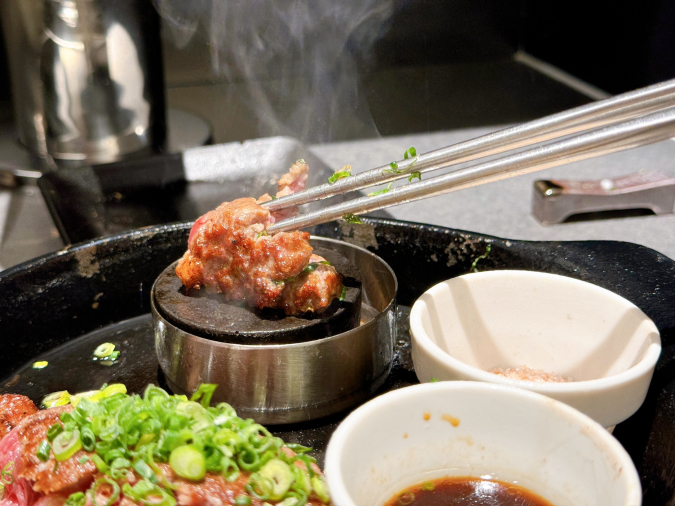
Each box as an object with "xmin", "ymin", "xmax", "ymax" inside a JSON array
[{"xmin": 155, "ymin": 0, "xmax": 393, "ymax": 142}]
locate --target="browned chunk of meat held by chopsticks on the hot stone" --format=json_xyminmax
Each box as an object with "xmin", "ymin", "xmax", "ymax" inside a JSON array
[{"xmin": 176, "ymin": 162, "xmax": 342, "ymax": 315}]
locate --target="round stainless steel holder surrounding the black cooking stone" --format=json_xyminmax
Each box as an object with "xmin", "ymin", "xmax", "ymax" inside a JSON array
[{"xmin": 151, "ymin": 237, "xmax": 397, "ymax": 424}]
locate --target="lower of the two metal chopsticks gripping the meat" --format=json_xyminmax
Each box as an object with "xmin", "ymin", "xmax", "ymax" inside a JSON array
[{"xmin": 267, "ymin": 107, "xmax": 675, "ymax": 232}]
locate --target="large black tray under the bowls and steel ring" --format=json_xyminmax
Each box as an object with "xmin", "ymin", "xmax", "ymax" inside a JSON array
[{"xmin": 0, "ymin": 219, "xmax": 675, "ymax": 505}]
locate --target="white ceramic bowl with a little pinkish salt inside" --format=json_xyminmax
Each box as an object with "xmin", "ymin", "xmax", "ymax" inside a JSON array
[{"xmin": 410, "ymin": 271, "xmax": 661, "ymax": 427}]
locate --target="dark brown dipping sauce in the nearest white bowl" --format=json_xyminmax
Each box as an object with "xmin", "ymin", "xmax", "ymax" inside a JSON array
[{"xmin": 385, "ymin": 476, "xmax": 553, "ymax": 506}]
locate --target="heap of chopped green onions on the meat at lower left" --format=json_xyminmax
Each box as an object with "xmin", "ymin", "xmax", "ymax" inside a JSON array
[{"xmin": 36, "ymin": 384, "xmax": 330, "ymax": 506}]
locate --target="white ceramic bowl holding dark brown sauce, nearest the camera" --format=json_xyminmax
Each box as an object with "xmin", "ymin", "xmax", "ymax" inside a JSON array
[{"xmin": 325, "ymin": 381, "xmax": 642, "ymax": 506}]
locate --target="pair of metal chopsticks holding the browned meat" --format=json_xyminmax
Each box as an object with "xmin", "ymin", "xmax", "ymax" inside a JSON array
[{"xmin": 262, "ymin": 79, "xmax": 675, "ymax": 232}]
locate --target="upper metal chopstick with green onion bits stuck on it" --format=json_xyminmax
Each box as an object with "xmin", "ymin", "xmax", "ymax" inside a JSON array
[{"xmin": 262, "ymin": 79, "xmax": 675, "ymax": 211}]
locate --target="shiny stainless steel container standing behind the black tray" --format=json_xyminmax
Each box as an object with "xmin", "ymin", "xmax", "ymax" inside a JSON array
[{"xmin": 0, "ymin": 0, "xmax": 165, "ymax": 163}]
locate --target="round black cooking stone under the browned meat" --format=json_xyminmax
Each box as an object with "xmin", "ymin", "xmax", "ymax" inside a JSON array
[{"xmin": 153, "ymin": 248, "xmax": 361, "ymax": 344}]
